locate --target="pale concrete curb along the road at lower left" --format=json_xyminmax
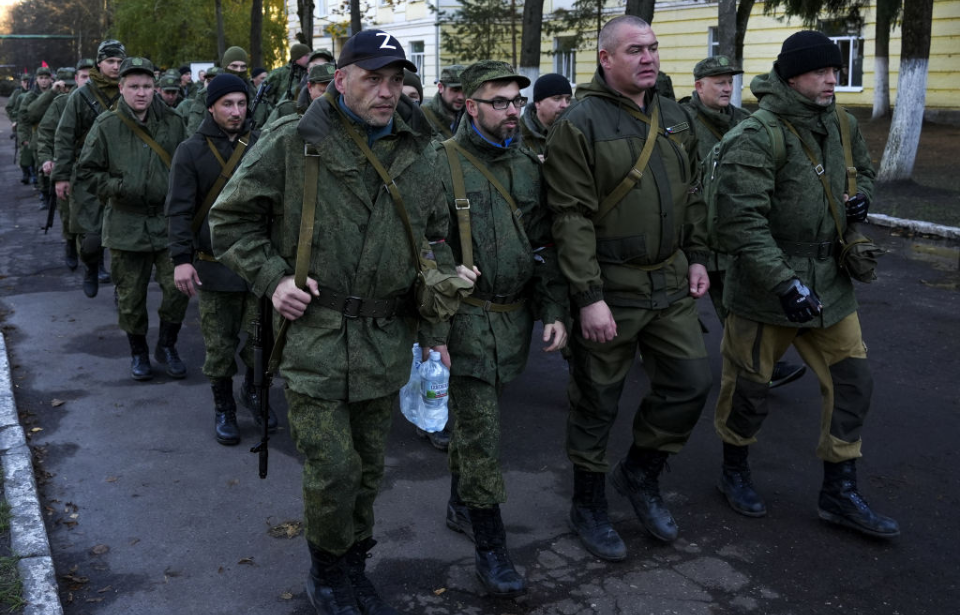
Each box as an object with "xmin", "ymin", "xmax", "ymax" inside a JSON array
[{"xmin": 0, "ymin": 333, "xmax": 63, "ymax": 615}]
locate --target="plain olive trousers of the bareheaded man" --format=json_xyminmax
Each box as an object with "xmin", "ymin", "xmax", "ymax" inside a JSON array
[{"xmin": 567, "ymin": 297, "xmax": 712, "ymax": 472}]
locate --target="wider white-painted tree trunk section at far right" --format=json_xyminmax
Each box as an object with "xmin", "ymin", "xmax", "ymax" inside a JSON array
[{"xmin": 877, "ymin": 58, "xmax": 929, "ymax": 182}]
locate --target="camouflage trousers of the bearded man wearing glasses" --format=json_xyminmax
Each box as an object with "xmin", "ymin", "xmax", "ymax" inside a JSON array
[{"xmin": 448, "ymin": 376, "xmax": 507, "ymax": 508}]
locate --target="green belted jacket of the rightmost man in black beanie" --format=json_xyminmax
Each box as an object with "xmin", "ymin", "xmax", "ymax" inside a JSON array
[{"xmin": 716, "ymin": 71, "xmax": 874, "ymax": 327}]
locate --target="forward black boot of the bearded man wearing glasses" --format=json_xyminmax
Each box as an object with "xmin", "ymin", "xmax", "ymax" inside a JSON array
[{"xmin": 467, "ymin": 505, "xmax": 527, "ymax": 598}]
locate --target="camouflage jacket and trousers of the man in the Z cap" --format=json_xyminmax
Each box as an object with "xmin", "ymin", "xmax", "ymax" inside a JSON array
[{"xmin": 210, "ymin": 80, "xmax": 462, "ymax": 556}]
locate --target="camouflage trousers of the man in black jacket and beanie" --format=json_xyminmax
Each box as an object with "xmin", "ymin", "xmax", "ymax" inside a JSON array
[{"xmin": 200, "ymin": 289, "xmax": 258, "ymax": 381}]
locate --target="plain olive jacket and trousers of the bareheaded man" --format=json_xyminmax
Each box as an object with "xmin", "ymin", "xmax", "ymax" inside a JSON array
[{"xmin": 544, "ymin": 69, "xmax": 710, "ymax": 472}]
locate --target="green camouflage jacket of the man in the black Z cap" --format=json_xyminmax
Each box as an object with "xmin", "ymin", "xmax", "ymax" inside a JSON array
[{"xmin": 209, "ymin": 92, "xmax": 453, "ymax": 401}]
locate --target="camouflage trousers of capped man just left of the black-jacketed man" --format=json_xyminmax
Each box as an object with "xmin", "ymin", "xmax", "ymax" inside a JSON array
[{"xmin": 110, "ymin": 248, "xmax": 190, "ymax": 335}]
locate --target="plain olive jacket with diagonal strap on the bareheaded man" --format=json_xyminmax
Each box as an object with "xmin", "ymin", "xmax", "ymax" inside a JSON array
[{"xmin": 544, "ymin": 68, "xmax": 709, "ymax": 309}]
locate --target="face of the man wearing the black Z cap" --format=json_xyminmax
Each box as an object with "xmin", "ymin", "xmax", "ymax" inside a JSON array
[{"xmin": 334, "ymin": 65, "xmax": 403, "ymax": 127}]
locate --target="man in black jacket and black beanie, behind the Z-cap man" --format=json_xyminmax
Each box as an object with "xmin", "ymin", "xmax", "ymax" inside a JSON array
[{"xmin": 166, "ymin": 74, "xmax": 277, "ymax": 445}]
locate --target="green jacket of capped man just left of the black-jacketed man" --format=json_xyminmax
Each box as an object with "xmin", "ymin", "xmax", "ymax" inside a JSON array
[{"xmin": 77, "ymin": 99, "xmax": 186, "ymax": 252}]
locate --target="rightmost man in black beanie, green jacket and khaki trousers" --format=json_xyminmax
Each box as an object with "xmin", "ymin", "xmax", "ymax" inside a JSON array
[{"xmin": 715, "ymin": 31, "xmax": 900, "ymax": 538}]
